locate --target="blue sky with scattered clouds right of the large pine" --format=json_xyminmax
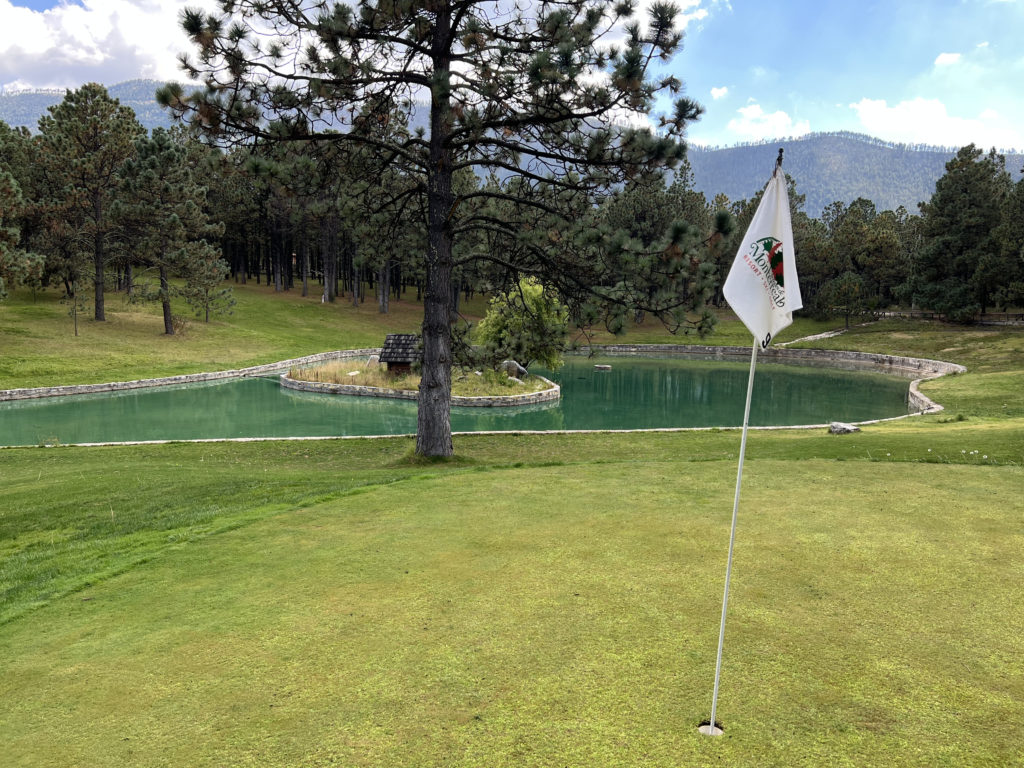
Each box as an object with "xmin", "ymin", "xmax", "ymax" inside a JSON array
[{"xmin": 655, "ymin": 0, "xmax": 1024, "ymax": 148}]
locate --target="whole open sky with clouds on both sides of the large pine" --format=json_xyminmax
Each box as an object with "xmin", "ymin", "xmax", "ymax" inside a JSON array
[{"xmin": 0, "ymin": 0, "xmax": 1024, "ymax": 150}]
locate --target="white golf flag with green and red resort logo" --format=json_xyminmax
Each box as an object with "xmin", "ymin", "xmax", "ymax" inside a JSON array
[{"xmin": 723, "ymin": 172, "xmax": 804, "ymax": 349}]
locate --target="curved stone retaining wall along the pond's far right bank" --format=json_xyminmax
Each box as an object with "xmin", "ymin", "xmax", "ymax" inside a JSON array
[{"xmin": 588, "ymin": 344, "xmax": 967, "ymax": 414}]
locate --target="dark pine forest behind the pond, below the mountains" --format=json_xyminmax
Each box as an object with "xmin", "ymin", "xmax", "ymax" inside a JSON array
[{"xmin": 0, "ymin": 85, "xmax": 1024, "ymax": 333}]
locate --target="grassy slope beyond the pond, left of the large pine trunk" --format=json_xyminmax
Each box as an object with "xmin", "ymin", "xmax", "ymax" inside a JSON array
[{"xmin": 0, "ymin": 284, "xmax": 446, "ymax": 389}]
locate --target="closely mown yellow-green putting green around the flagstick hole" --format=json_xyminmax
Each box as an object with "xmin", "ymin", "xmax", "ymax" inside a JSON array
[{"xmin": 0, "ymin": 450, "xmax": 1024, "ymax": 766}]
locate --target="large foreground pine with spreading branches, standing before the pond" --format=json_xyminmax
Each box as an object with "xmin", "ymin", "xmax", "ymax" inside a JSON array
[{"xmin": 165, "ymin": 0, "xmax": 700, "ymax": 456}]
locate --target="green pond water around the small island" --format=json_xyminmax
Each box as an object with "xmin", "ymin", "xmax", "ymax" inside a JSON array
[{"xmin": 0, "ymin": 357, "xmax": 908, "ymax": 445}]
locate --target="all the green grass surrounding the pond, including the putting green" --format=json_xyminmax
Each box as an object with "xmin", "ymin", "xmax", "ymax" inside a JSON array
[{"xmin": 0, "ymin": 287, "xmax": 1024, "ymax": 766}]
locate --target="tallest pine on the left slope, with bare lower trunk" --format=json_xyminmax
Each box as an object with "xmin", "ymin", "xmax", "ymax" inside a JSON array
[{"xmin": 39, "ymin": 83, "xmax": 144, "ymax": 321}]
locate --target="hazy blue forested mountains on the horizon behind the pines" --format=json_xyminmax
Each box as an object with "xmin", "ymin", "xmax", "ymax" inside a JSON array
[{"xmin": 0, "ymin": 80, "xmax": 1024, "ymax": 216}]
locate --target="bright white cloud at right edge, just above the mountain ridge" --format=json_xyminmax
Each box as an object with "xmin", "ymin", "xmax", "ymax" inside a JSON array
[{"xmin": 850, "ymin": 97, "xmax": 1024, "ymax": 148}]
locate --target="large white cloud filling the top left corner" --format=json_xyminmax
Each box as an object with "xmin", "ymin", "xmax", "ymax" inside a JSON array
[{"xmin": 0, "ymin": 0, "xmax": 220, "ymax": 88}]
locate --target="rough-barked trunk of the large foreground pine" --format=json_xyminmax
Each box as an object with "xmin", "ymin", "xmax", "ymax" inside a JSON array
[{"xmin": 416, "ymin": 16, "xmax": 455, "ymax": 456}]
